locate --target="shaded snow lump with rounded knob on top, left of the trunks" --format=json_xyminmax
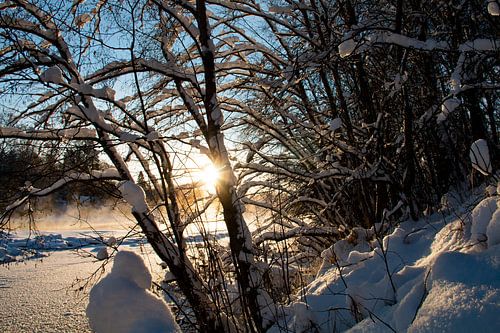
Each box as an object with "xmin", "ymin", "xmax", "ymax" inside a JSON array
[{"xmin": 87, "ymin": 251, "xmax": 180, "ymax": 333}]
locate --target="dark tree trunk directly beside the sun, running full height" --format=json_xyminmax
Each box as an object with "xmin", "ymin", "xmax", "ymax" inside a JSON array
[{"xmin": 196, "ymin": 0, "xmax": 265, "ymax": 332}]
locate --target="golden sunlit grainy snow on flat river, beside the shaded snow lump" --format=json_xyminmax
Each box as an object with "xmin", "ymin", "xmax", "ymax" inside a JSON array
[{"xmin": 0, "ymin": 250, "xmax": 99, "ymax": 333}]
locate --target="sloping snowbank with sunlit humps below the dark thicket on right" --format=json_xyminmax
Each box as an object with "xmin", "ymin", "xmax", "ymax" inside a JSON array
[{"xmin": 273, "ymin": 188, "xmax": 500, "ymax": 332}]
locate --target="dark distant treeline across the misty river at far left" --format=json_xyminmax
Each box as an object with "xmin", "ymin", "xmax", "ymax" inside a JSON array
[{"xmin": 0, "ymin": 140, "xmax": 117, "ymax": 210}]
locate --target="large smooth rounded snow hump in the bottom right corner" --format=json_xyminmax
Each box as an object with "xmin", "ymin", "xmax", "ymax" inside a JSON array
[{"xmin": 408, "ymin": 248, "xmax": 500, "ymax": 332}]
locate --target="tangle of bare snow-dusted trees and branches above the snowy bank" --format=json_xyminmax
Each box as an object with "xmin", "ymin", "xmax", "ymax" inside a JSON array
[{"xmin": 0, "ymin": 0, "xmax": 500, "ymax": 332}]
